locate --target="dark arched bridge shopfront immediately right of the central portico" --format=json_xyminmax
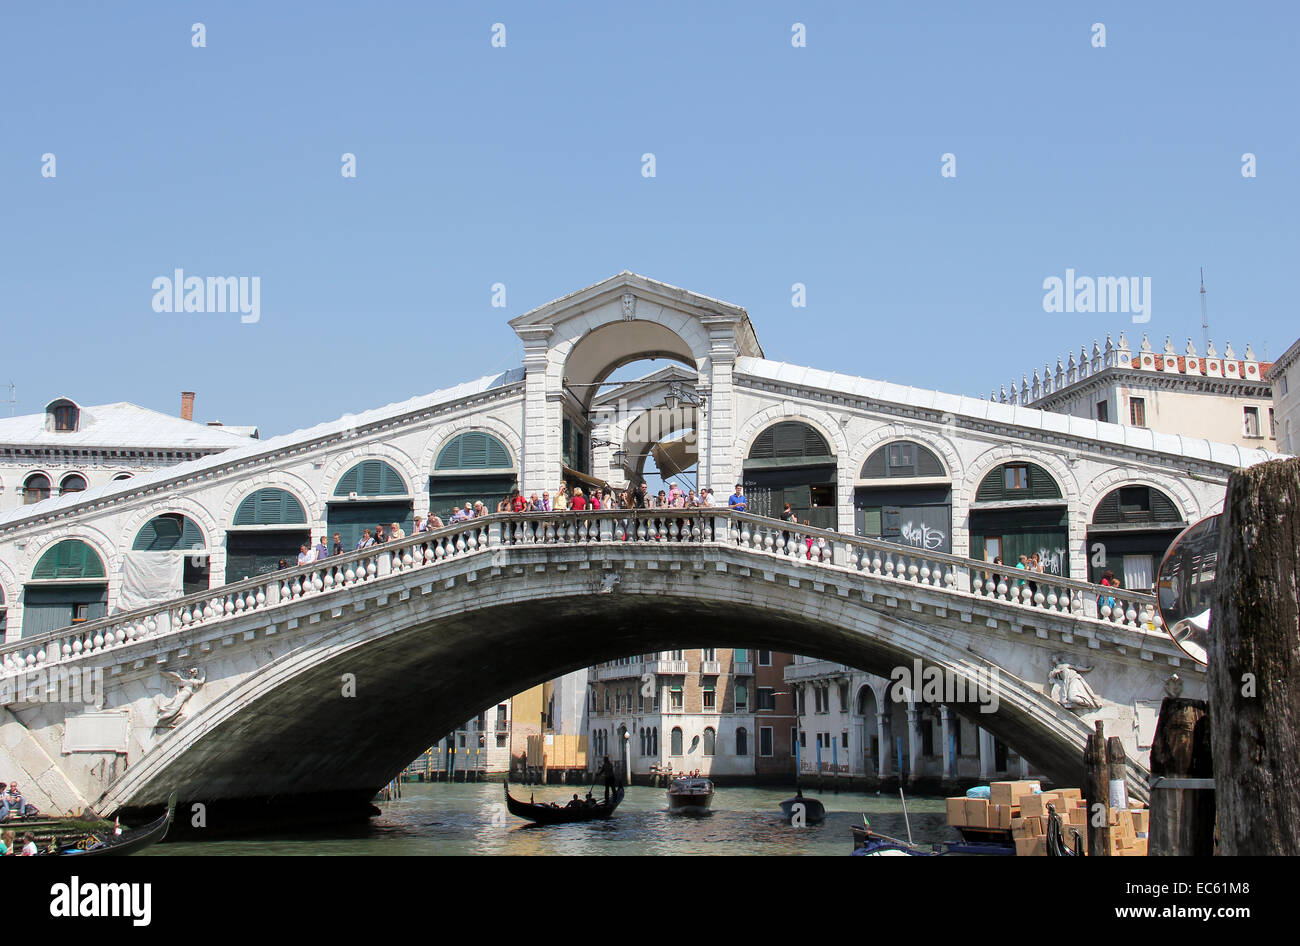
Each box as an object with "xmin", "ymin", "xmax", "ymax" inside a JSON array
[{"xmin": 741, "ymin": 421, "xmax": 839, "ymax": 529}]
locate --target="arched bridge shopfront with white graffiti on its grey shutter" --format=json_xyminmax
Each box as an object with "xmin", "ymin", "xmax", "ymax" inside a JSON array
[{"xmin": 853, "ymin": 441, "xmax": 953, "ymax": 552}]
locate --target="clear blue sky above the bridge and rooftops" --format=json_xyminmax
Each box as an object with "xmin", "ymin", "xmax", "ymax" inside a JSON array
[{"xmin": 0, "ymin": 0, "xmax": 1300, "ymax": 435}]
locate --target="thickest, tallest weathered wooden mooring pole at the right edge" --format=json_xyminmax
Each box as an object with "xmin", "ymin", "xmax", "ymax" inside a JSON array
[{"xmin": 1206, "ymin": 457, "xmax": 1300, "ymax": 856}]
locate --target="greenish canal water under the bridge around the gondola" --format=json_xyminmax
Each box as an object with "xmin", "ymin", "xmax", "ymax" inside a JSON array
[{"xmin": 142, "ymin": 782, "xmax": 956, "ymax": 856}]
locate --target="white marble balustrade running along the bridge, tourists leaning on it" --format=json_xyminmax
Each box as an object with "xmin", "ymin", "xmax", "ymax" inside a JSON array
[{"xmin": 0, "ymin": 508, "xmax": 1158, "ymax": 678}]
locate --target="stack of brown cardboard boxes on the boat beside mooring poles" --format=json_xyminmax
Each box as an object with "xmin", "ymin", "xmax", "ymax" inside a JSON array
[{"xmin": 948, "ymin": 781, "xmax": 1149, "ymax": 856}]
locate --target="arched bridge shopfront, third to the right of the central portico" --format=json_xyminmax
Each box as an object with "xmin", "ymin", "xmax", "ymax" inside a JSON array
[{"xmin": 970, "ymin": 463, "xmax": 1070, "ymax": 577}]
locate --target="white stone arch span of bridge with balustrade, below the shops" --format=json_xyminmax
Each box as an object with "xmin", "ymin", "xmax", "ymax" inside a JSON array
[{"xmin": 0, "ymin": 509, "xmax": 1190, "ymax": 817}]
